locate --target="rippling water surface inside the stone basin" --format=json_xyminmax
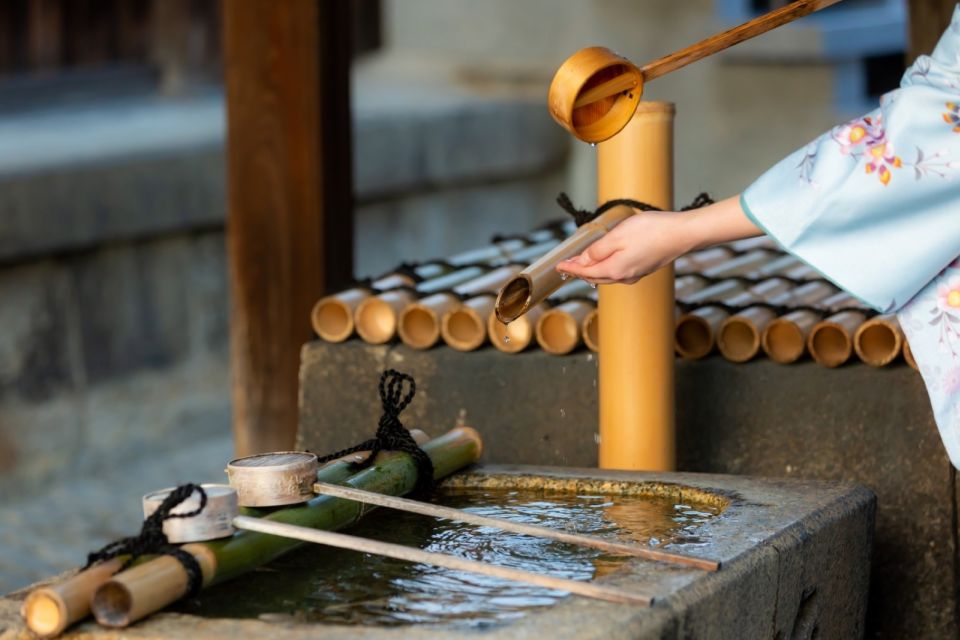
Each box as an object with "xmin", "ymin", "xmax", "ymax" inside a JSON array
[{"xmin": 178, "ymin": 490, "xmax": 718, "ymax": 627}]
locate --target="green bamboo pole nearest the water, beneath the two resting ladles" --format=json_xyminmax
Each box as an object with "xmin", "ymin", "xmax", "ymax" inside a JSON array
[{"xmin": 92, "ymin": 427, "xmax": 482, "ymax": 627}]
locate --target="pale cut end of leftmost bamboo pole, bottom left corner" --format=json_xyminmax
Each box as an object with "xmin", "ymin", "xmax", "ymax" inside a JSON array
[{"xmin": 21, "ymin": 558, "xmax": 123, "ymax": 638}]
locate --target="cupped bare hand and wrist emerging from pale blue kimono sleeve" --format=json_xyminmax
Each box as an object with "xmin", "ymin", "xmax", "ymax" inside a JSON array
[{"xmin": 557, "ymin": 196, "xmax": 761, "ymax": 284}]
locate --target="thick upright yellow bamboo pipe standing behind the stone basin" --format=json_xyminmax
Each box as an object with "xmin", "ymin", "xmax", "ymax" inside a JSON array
[{"xmin": 597, "ymin": 102, "xmax": 676, "ymax": 471}]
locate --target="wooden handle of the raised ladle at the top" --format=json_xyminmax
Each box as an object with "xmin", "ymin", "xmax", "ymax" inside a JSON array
[{"xmin": 640, "ymin": 0, "xmax": 840, "ymax": 81}]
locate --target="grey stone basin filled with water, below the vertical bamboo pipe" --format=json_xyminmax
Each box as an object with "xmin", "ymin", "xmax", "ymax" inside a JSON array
[{"xmin": 0, "ymin": 466, "xmax": 875, "ymax": 640}]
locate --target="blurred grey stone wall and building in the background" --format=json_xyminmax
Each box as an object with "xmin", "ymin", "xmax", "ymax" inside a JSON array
[{"xmin": 0, "ymin": 0, "xmax": 906, "ymax": 591}]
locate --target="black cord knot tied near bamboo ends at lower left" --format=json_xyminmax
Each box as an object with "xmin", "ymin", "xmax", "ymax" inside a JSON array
[{"xmin": 83, "ymin": 484, "xmax": 207, "ymax": 597}]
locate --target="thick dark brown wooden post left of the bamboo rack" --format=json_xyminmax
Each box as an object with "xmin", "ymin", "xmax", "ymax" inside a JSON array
[{"xmin": 222, "ymin": 0, "xmax": 353, "ymax": 455}]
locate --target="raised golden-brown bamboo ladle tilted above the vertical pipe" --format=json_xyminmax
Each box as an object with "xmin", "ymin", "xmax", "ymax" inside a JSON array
[{"xmin": 547, "ymin": 0, "xmax": 840, "ymax": 142}]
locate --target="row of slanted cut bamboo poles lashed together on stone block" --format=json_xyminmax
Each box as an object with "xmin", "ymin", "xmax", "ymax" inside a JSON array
[{"xmin": 311, "ymin": 222, "xmax": 916, "ymax": 368}]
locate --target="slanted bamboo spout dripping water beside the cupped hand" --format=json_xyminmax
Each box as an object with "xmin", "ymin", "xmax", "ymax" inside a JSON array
[{"xmin": 494, "ymin": 206, "xmax": 635, "ymax": 324}]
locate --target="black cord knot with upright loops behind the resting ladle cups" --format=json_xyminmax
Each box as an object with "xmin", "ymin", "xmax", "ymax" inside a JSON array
[{"xmin": 318, "ymin": 369, "xmax": 433, "ymax": 493}]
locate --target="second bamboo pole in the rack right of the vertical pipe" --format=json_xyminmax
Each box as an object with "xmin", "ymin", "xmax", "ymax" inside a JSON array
[{"xmin": 717, "ymin": 278, "xmax": 836, "ymax": 362}]
